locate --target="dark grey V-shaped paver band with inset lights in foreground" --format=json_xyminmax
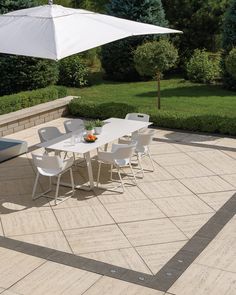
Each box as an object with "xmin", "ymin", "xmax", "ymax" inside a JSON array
[{"xmin": 0, "ymin": 193, "xmax": 236, "ymax": 292}]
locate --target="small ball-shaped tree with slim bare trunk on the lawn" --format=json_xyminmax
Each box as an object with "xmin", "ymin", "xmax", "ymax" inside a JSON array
[{"xmin": 134, "ymin": 39, "xmax": 178, "ymax": 109}]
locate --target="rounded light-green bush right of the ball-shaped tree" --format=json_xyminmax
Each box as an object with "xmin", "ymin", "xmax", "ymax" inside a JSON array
[{"xmin": 186, "ymin": 49, "xmax": 221, "ymax": 83}]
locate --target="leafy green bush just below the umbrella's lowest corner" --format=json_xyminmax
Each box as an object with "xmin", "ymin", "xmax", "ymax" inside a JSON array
[{"xmin": 58, "ymin": 55, "xmax": 88, "ymax": 87}]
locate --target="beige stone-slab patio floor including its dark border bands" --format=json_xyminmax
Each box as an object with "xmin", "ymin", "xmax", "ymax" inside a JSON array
[{"xmin": 0, "ymin": 118, "xmax": 236, "ymax": 295}]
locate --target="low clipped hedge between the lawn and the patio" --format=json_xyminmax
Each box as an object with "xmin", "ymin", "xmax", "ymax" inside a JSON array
[{"xmin": 69, "ymin": 98, "xmax": 236, "ymax": 135}]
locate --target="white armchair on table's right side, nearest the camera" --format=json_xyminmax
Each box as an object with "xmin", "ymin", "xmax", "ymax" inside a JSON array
[{"xmin": 97, "ymin": 143, "xmax": 136, "ymax": 192}]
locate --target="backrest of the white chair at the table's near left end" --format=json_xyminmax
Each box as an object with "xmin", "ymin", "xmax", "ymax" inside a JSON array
[{"xmin": 32, "ymin": 154, "xmax": 63, "ymax": 172}]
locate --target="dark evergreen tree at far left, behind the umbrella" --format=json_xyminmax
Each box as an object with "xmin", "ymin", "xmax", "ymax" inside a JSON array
[{"xmin": 0, "ymin": 0, "xmax": 58, "ymax": 95}]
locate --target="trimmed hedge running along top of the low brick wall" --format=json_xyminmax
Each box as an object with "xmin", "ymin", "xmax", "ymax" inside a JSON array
[{"xmin": 0, "ymin": 86, "xmax": 67, "ymax": 115}]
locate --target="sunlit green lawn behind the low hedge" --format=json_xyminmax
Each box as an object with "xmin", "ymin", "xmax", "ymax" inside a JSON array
[{"xmin": 68, "ymin": 79, "xmax": 236, "ymax": 119}]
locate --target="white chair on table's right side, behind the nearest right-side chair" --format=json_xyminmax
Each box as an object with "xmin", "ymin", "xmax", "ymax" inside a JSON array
[{"xmin": 119, "ymin": 129, "xmax": 156, "ymax": 176}]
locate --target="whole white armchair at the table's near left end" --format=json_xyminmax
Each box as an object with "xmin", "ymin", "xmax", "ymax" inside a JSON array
[{"xmin": 32, "ymin": 154, "xmax": 74, "ymax": 205}]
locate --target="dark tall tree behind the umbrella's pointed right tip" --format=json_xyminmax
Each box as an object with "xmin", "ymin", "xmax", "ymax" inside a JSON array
[{"xmin": 162, "ymin": 0, "xmax": 231, "ymax": 61}]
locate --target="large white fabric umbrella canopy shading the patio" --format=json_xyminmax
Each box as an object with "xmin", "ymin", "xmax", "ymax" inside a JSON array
[{"xmin": 0, "ymin": 5, "xmax": 181, "ymax": 60}]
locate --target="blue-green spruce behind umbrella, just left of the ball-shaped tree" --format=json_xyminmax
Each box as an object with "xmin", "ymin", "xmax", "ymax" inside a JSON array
[{"xmin": 101, "ymin": 0, "xmax": 167, "ymax": 81}]
